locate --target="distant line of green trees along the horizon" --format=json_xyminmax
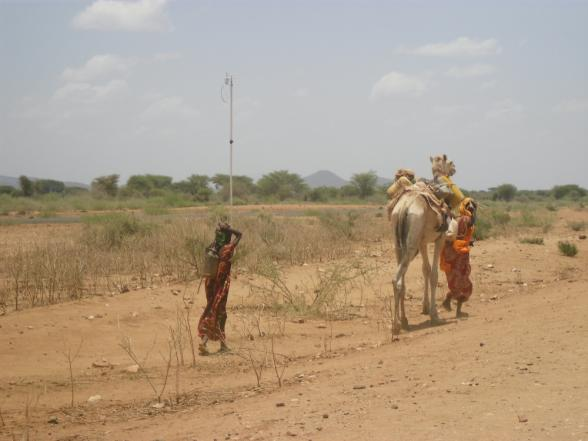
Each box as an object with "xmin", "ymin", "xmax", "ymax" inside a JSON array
[{"xmin": 0, "ymin": 174, "xmax": 588, "ymax": 202}]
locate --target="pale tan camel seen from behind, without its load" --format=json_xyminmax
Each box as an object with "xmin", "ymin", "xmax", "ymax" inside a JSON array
[{"xmin": 391, "ymin": 155, "xmax": 455, "ymax": 334}]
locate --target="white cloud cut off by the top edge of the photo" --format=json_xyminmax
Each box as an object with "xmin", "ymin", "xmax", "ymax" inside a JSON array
[{"xmin": 73, "ymin": 0, "xmax": 171, "ymax": 32}]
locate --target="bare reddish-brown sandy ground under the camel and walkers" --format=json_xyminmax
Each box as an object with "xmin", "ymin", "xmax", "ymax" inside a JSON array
[{"xmin": 0, "ymin": 211, "xmax": 588, "ymax": 441}]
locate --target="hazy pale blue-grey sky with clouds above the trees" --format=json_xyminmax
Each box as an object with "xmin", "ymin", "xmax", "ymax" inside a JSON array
[{"xmin": 0, "ymin": 0, "xmax": 588, "ymax": 189}]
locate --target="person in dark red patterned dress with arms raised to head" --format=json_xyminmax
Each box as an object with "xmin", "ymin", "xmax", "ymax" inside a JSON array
[{"xmin": 198, "ymin": 222, "xmax": 242, "ymax": 355}]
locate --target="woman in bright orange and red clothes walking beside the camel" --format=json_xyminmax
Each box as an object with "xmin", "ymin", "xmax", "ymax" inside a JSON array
[{"xmin": 439, "ymin": 198, "xmax": 476, "ymax": 318}]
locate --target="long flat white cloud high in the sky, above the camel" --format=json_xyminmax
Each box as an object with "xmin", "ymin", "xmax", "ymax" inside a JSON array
[{"xmin": 400, "ymin": 37, "xmax": 502, "ymax": 57}]
